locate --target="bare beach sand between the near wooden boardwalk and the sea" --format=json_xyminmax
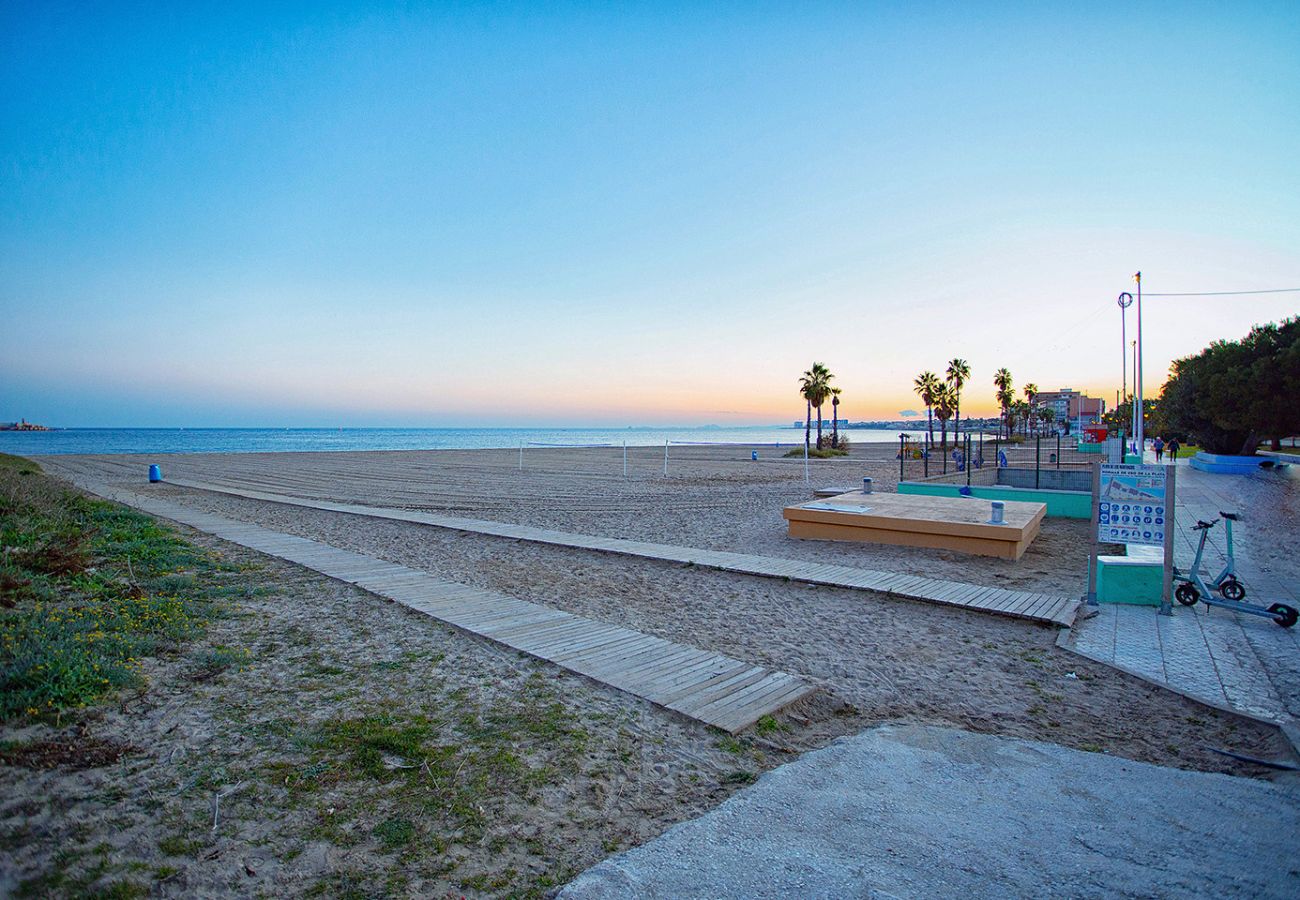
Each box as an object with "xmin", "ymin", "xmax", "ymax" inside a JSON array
[{"xmin": 43, "ymin": 445, "xmax": 1284, "ymax": 771}]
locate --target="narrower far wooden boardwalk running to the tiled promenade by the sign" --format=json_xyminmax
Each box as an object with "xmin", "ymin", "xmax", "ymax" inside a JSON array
[{"xmin": 159, "ymin": 479, "xmax": 1079, "ymax": 628}]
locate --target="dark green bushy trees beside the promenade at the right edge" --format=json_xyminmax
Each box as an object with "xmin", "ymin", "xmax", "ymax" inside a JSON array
[{"xmin": 1153, "ymin": 316, "xmax": 1300, "ymax": 457}]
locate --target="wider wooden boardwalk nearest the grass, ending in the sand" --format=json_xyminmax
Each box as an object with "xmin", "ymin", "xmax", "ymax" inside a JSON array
[{"xmin": 79, "ymin": 481, "xmax": 816, "ymax": 734}]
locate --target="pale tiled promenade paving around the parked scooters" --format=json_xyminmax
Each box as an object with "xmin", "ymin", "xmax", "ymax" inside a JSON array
[{"xmin": 1058, "ymin": 460, "xmax": 1300, "ymax": 724}]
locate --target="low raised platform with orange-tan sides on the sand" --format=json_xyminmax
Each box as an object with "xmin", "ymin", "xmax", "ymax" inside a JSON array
[{"xmin": 784, "ymin": 490, "xmax": 1048, "ymax": 559}]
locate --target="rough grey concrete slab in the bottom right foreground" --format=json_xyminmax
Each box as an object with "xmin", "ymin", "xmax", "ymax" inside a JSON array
[{"xmin": 560, "ymin": 726, "xmax": 1300, "ymax": 900}]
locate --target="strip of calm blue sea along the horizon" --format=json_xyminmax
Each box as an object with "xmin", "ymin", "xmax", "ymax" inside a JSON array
[{"xmin": 0, "ymin": 425, "xmax": 920, "ymax": 457}]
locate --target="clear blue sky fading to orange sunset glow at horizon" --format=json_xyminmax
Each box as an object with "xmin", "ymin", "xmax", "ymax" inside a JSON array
[{"xmin": 0, "ymin": 1, "xmax": 1300, "ymax": 427}]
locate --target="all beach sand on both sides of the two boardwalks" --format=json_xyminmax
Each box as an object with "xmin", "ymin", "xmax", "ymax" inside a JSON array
[{"xmin": 0, "ymin": 449, "xmax": 1287, "ymax": 896}]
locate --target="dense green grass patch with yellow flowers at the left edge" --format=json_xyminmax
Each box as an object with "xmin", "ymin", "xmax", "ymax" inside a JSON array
[{"xmin": 0, "ymin": 457, "xmax": 233, "ymax": 721}]
